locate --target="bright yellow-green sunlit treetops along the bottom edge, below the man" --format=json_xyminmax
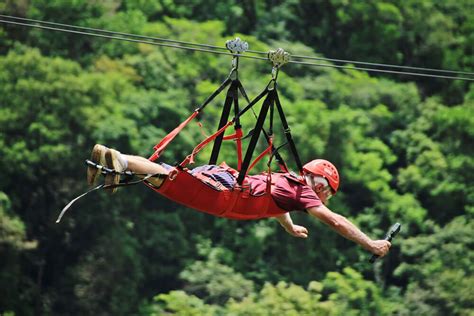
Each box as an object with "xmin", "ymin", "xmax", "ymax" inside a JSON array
[{"xmin": 145, "ymin": 268, "xmax": 396, "ymax": 316}]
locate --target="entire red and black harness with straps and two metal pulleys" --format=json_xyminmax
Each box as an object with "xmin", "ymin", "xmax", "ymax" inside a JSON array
[{"xmin": 58, "ymin": 38, "xmax": 303, "ymax": 222}]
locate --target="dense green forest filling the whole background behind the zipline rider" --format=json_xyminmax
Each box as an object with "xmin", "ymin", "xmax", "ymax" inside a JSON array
[{"xmin": 0, "ymin": 0, "xmax": 474, "ymax": 315}]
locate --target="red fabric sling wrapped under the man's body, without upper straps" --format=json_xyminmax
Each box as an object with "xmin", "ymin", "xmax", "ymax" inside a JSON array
[{"xmin": 150, "ymin": 168, "xmax": 288, "ymax": 220}]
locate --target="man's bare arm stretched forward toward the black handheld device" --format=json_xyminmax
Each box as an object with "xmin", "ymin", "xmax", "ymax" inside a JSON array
[{"xmin": 307, "ymin": 205, "xmax": 391, "ymax": 257}]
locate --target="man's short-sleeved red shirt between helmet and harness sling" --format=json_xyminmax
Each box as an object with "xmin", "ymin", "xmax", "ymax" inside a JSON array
[{"xmin": 246, "ymin": 174, "xmax": 323, "ymax": 211}]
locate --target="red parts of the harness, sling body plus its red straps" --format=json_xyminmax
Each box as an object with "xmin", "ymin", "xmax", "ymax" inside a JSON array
[{"xmin": 147, "ymin": 94, "xmax": 288, "ymax": 220}]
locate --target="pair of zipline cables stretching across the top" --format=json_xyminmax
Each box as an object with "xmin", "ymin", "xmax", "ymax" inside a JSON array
[{"xmin": 0, "ymin": 14, "xmax": 474, "ymax": 81}]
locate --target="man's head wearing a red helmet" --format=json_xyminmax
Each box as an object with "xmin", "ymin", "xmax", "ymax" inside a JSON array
[{"xmin": 303, "ymin": 159, "xmax": 339, "ymax": 204}]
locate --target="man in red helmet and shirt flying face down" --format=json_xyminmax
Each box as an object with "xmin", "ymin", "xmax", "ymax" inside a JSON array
[{"xmin": 87, "ymin": 144, "xmax": 391, "ymax": 257}]
